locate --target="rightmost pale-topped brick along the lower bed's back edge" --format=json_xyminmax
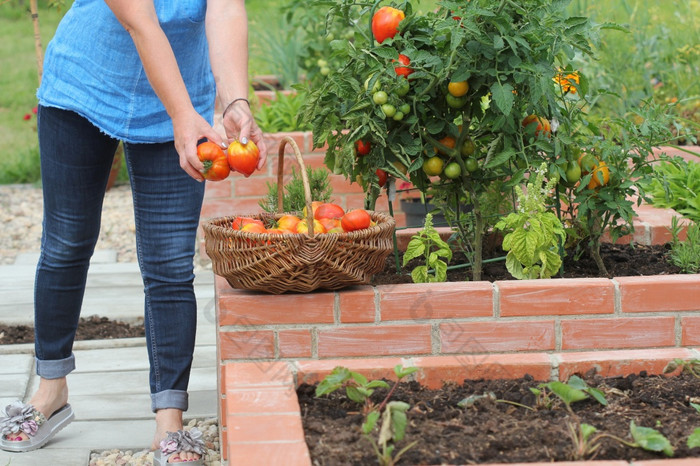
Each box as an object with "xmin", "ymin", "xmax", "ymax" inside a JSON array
[{"xmin": 556, "ymin": 348, "xmax": 692, "ymax": 380}]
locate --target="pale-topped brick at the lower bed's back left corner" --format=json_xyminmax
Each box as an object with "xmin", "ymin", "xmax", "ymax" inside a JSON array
[{"xmin": 224, "ymin": 361, "xmax": 294, "ymax": 390}]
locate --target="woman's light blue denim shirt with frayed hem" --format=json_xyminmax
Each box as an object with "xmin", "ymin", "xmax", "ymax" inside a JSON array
[{"xmin": 37, "ymin": 0, "xmax": 216, "ymax": 143}]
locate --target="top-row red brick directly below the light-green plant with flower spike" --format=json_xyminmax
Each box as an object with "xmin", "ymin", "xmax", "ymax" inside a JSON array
[{"xmin": 496, "ymin": 278, "xmax": 615, "ymax": 317}]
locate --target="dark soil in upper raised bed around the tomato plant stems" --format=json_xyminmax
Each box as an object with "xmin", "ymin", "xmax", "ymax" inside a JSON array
[{"xmin": 372, "ymin": 243, "xmax": 680, "ymax": 285}]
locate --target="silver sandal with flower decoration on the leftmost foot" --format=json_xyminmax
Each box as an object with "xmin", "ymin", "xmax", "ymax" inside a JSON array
[{"xmin": 0, "ymin": 401, "xmax": 75, "ymax": 452}]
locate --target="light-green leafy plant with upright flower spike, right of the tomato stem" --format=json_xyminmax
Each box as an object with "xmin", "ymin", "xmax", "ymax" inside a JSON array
[{"xmin": 495, "ymin": 164, "xmax": 566, "ymax": 279}]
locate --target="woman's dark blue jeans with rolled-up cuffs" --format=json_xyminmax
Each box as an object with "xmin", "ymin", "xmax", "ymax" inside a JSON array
[{"xmin": 34, "ymin": 106, "xmax": 204, "ymax": 412}]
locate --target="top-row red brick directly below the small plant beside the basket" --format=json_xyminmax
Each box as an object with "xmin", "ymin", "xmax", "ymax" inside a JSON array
[{"xmin": 377, "ymin": 282, "xmax": 493, "ymax": 321}]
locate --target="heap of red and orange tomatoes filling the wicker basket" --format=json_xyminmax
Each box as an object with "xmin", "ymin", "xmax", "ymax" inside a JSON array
[{"xmin": 231, "ymin": 201, "xmax": 376, "ymax": 235}]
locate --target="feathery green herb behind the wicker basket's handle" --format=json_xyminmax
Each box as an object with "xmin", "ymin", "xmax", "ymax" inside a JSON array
[{"xmin": 258, "ymin": 167, "xmax": 333, "ymax": 212}]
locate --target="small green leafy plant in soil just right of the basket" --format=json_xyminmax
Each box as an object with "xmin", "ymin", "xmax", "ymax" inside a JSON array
[{"xmin": 403, "ymin": 213, "xmax": 452, "ymax": 283}]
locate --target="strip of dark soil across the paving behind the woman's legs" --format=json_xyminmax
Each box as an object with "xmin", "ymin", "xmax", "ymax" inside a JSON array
[{"xmin": 0, "ymin": 316, "xmax": 146, "ymax": 345}]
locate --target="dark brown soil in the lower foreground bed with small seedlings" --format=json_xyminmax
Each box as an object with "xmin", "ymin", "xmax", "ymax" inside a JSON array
[{"xmin": 297, "ymin": 373, "xmax": 700, "ymax": 466}]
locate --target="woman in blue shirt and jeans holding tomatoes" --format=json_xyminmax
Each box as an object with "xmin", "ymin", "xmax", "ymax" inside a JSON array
[{"xmin": 0, "ymin": 0, "xmax": 266, "ymax": 464}]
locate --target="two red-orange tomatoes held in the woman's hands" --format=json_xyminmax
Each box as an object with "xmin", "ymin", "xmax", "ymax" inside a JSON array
[{"xmin": 197, "ymin": 140, "xmax": 260, "ymax": 181}]
